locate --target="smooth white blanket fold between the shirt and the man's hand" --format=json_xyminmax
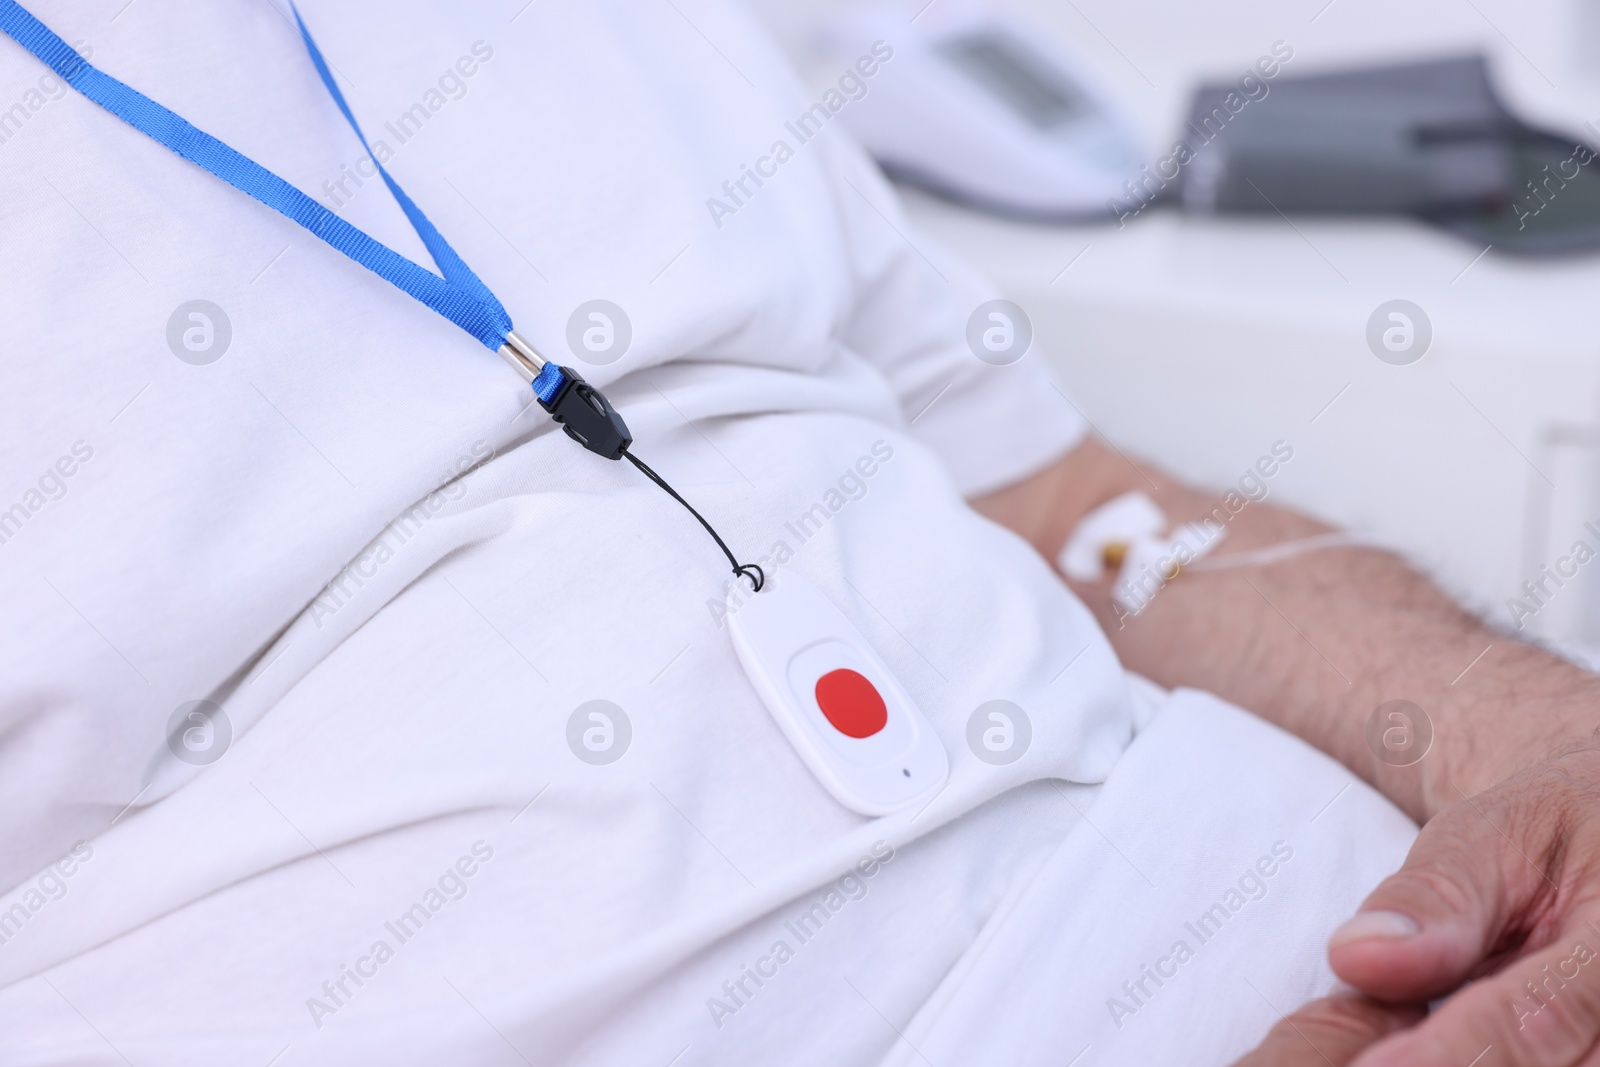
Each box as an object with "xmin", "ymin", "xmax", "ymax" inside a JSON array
[{"xmin": 883, "ymin": 689, "xmax": 1416, "ymax": 1067}]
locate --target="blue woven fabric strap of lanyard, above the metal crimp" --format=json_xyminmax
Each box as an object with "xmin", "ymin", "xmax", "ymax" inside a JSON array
[{"xmin": 0, "ymin": 0, "xmax": 512, "ymax": 352}]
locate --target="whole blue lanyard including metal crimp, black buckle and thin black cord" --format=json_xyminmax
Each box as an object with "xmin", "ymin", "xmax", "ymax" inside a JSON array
[{"xmin": 0, "ymin": 0, "xmax": 765, "ymax": 590}]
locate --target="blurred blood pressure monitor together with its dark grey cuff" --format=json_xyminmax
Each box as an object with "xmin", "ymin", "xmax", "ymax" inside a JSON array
[{"xmin": 818, "ymin": 0, "xmax": 1600, "ymax": 256}]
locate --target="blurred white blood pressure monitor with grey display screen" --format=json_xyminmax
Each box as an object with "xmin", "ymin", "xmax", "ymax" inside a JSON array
[{"xmin": 821, "ymin": 2, "xmax": 1142, "ymax": 218}]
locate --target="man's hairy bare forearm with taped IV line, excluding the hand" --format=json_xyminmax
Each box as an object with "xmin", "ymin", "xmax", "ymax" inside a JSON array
[{"xmin": 974, "ymin": 442, "xmax": 1600, "ymax": 821}]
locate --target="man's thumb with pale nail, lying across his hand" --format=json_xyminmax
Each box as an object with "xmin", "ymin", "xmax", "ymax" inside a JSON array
[{"xmin": 1328, "ymin": 806, "xmax": 1547, "ymax": 1001}]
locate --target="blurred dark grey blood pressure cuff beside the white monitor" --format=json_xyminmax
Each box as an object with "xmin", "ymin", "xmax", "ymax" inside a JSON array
[{"xmin": 1162, "ymin": 56, "xmax": 1600, "ymax": 254}]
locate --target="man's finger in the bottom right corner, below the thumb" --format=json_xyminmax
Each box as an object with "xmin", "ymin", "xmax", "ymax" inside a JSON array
[{"xmin": 1357, "ymin": 925, "xmax": 1600, "ymax": 1067}]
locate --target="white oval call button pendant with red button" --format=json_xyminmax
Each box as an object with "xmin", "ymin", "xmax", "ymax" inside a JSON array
[{"xmin": 728, "ymin": 571, "xmax": 950, "ymax": 816}]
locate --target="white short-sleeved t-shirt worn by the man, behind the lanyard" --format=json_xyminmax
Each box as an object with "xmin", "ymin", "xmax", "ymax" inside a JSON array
[{"xmin": 0, "ymin": 0, "xmax": 1414, "ymax": 1065}]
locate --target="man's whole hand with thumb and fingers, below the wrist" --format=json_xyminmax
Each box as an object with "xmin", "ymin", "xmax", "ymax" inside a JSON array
[{"xmin": 1242, "ymin": 742, "xmax": 1600, "ymax": 1067}]
